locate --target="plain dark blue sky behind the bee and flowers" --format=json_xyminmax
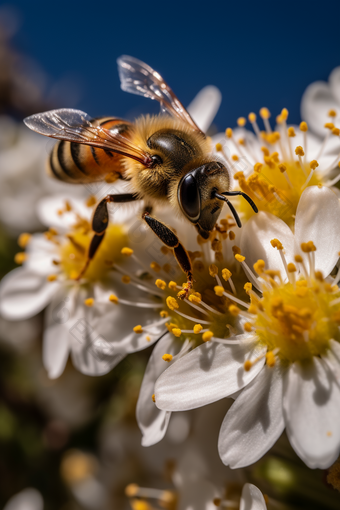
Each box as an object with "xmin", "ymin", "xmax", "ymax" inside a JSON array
[{"xmin": 4, "ymin": 0, "xmax": 340, "ymax": 129}]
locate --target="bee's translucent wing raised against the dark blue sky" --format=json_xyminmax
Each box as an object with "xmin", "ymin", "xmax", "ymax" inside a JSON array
[{"xmin": 117, "ymin": 55, "xmax": 201, "ymax": 132}]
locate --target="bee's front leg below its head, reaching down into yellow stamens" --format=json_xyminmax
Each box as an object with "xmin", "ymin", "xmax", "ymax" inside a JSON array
[{"xmin": 143, "ymin": 212, "xmax": 194, "ymax": 299}]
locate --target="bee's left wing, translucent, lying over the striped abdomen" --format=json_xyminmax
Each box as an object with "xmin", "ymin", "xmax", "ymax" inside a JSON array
[{"xmin": 24, "ymin": 108, "xmax": 152, "ymax": 166}]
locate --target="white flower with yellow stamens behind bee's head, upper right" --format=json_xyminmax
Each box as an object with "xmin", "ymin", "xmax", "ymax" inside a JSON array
[{"xmin": 214, "ymin": 108, "xmax": 340, "ymax": 227}]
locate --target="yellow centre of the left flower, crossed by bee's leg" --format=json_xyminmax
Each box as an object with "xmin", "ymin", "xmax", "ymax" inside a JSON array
[{"xmin": 60, "ymin": 220, "xmax": 128, "ymax": 281}]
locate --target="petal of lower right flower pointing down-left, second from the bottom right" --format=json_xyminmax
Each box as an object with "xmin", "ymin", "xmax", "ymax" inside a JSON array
[{"xmin": 218, "ymin": 365, "xmax": 285, "ymax": 469}]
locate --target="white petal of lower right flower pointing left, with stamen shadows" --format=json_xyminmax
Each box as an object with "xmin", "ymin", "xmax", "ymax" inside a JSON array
[{"xmin": 155, "ymin": 335, "xmax": 265, "ymax": 411}]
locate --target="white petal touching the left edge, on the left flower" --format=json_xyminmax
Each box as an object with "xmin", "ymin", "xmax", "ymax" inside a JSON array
[{"xmin": 0, "ymin": 267, "xmax": 60, "ymax": 320}]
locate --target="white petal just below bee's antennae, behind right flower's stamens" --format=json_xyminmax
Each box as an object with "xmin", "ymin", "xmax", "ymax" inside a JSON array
[{"xmin": 240, "ymin": 211, "xmax": 294, "ymax": 277}]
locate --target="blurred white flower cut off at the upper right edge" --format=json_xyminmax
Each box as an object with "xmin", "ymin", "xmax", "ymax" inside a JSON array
[{"xmin": 301, "ymin": 67, "xmax": 340, "ymax": 137}]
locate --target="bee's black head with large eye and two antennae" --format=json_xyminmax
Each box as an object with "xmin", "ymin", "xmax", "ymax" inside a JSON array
[{"xmin": 177, "ymin": 161, "xmax": 257, "ymax": 239}]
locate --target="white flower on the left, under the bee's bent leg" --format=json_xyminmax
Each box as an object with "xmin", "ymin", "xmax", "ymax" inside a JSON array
[{"xmin": 0, "ymin": 197, "xmax": 165, "ymax": 378}]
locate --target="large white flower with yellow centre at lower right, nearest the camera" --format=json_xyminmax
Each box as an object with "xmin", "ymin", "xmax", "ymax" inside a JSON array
[{"xmin": 155, "ymin": 186, "xmax": 340, "ymax": 468}]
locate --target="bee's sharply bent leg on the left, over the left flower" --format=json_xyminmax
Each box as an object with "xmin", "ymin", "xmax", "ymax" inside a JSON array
[{"xmin": 77, "ymin": 193, "xmax": 138, "ymax": 280}]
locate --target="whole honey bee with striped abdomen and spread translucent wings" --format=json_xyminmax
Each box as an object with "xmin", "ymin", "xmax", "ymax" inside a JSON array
[{"xmin": 24, "ymin": 55, "xmax": 257, "ymax": 293}]
